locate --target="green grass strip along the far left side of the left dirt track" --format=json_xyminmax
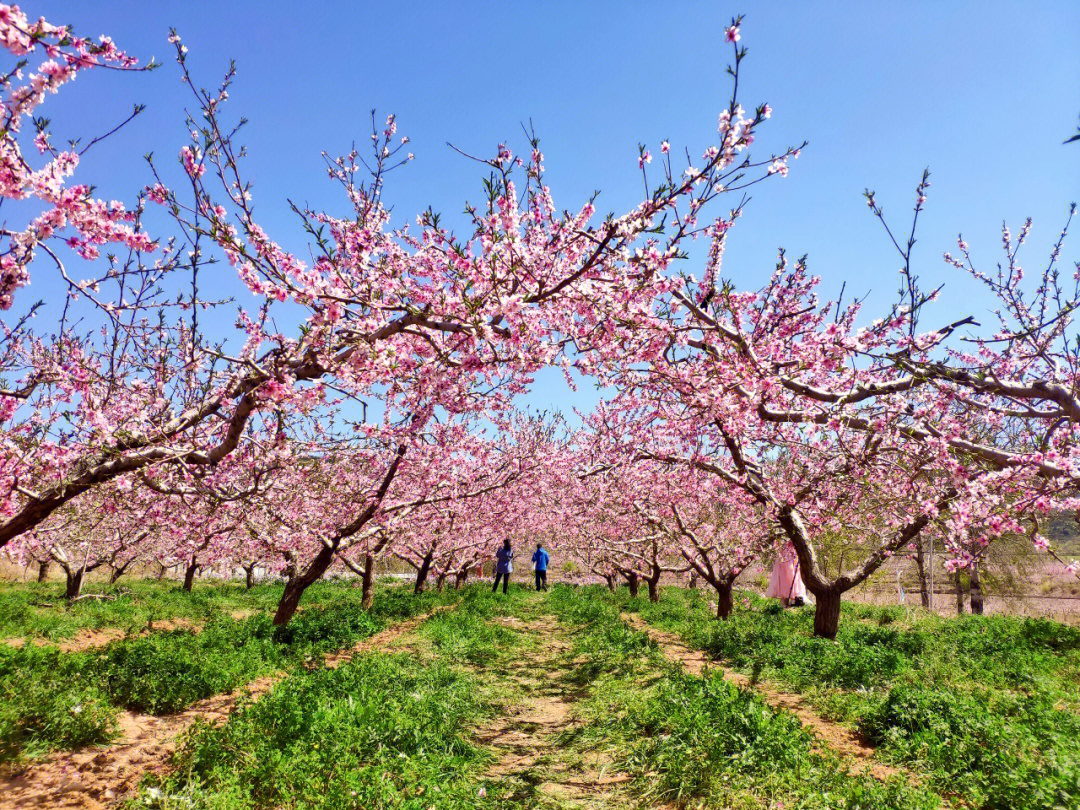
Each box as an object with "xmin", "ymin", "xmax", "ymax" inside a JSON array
[{"xmin": 0, "ymin": 589, "xmax": 457, "ymax": 761}]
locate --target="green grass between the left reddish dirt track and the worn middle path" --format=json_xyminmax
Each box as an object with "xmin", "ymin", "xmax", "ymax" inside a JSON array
[{"xmin": 133, "ymin": 585, "xmax": 529, "ymax": 810}]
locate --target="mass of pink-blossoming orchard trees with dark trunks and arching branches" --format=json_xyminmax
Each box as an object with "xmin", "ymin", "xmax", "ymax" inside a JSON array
[{"xmin": 0, "ymin": 5, "xmax": 1080, "ymax": 637}]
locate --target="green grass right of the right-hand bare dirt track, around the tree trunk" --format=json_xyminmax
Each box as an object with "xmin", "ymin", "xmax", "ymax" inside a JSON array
[{"xmin": 618, "ymin": 589, "xmax": 1080, "ymax": 810}]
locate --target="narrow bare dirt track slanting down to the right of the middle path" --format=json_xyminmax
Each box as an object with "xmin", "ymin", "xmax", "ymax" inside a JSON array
[{"xmin": 622, "ymin": 613, "xmax": 910, "ymax": 781}]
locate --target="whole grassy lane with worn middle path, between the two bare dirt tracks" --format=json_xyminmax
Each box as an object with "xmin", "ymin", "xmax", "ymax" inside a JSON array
[{"xmin": 135, "ymin": 586, "xmax": 941, "ymax": 810}]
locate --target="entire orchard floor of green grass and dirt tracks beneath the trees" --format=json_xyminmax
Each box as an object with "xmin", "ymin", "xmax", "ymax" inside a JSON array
[{"xmin": 0, "ymin": 580, "xmax": 1080, "ymax": 810}]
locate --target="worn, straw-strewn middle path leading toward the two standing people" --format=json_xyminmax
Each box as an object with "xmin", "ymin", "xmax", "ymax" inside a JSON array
[{"xmin": 476, "ymin": 616, "xmax": 633, "ymax": 810}]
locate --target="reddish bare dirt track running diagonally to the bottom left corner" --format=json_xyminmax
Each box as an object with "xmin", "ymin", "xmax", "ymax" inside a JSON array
[{"xmin": 0, "ymin": 605, "xmax": 442, "ymax": 810}]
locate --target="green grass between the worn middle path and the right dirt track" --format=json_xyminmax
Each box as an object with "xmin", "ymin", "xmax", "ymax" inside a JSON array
[{"xmin": 549, "ymin": 588, "xmax": 940, "ymax": 810}]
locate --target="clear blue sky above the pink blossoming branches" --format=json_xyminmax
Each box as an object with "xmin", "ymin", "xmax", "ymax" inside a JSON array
[{"xmin": 31, "ymin": 0, "xmax": 1080, "ymax": 419}]
